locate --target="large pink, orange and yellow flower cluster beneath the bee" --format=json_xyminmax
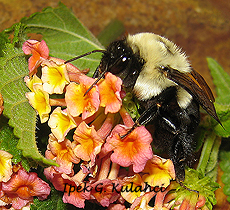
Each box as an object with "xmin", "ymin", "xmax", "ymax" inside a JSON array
[{"xmin": 23, "ymin": 40, "xmax": 208, "ymax": 209}]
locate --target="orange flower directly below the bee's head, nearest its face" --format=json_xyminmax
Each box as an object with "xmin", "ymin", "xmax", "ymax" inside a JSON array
[{"xmin": 98, "ymin": 73, "xmax": 122, "ymax": 114}]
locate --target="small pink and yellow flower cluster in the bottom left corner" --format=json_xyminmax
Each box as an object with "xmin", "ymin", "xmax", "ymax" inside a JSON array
[{"xmin": 0, "ymin": 150, "xmax": 50, "ymax": 209}]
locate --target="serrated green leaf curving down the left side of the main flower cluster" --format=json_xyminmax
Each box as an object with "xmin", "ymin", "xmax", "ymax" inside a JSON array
[{"xmin": 0, "ymin": 43, "xmax": 57, "ymax": 165}]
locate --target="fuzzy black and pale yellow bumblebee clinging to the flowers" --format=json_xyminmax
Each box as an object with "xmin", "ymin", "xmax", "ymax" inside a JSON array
[{"xmin": 67, "ymin": 33, "xmax": 221, "ymax": 183}]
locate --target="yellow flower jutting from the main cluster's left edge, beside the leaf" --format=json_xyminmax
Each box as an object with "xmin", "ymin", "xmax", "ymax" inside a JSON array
[{"xmin": 26, "ymin": 84, "xmax": 51, "ymax": 123}]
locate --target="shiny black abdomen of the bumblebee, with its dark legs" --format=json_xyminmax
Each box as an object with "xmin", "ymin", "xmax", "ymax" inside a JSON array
[{"xmin": 154, "ymin": 97, "xmax": 200, "ymax": 182}]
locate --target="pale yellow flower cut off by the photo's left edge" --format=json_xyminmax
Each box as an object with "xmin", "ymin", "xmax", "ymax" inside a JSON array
[{"xmin": 0, "ymin": 150, "xmax": 13, "ymax": 182}]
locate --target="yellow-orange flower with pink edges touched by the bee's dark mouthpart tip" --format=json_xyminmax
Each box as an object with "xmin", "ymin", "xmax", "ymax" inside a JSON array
[{"xmin": 65, "ymin": 75, "xmax": 100, "ymax": 120}]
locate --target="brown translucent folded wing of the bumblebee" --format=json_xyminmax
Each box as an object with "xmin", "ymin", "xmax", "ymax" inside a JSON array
[{"xmin": 165, "ymin": 69, "xmax": 222, "ymax": 125}]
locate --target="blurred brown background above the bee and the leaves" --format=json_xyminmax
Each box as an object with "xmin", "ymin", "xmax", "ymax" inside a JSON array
[{"xmin": 0, "ymin": 0, "xmax": 230, "ymax": 209}]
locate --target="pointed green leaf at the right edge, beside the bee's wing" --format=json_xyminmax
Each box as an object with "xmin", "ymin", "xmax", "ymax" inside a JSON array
[{"xmin": 207, "ymin": 58, "xmax": 230, "ymax": 105}]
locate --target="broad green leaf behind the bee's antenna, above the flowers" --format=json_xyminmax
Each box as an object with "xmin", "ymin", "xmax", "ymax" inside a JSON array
[{"xmin": 22, "ymin": 3, "xmax": 103, "ymax": 76}]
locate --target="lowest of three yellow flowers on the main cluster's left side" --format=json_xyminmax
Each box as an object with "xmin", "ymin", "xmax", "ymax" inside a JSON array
[{"xmin": 48, "ymin": 107, "xmax": 77, "ymax": 142}]
